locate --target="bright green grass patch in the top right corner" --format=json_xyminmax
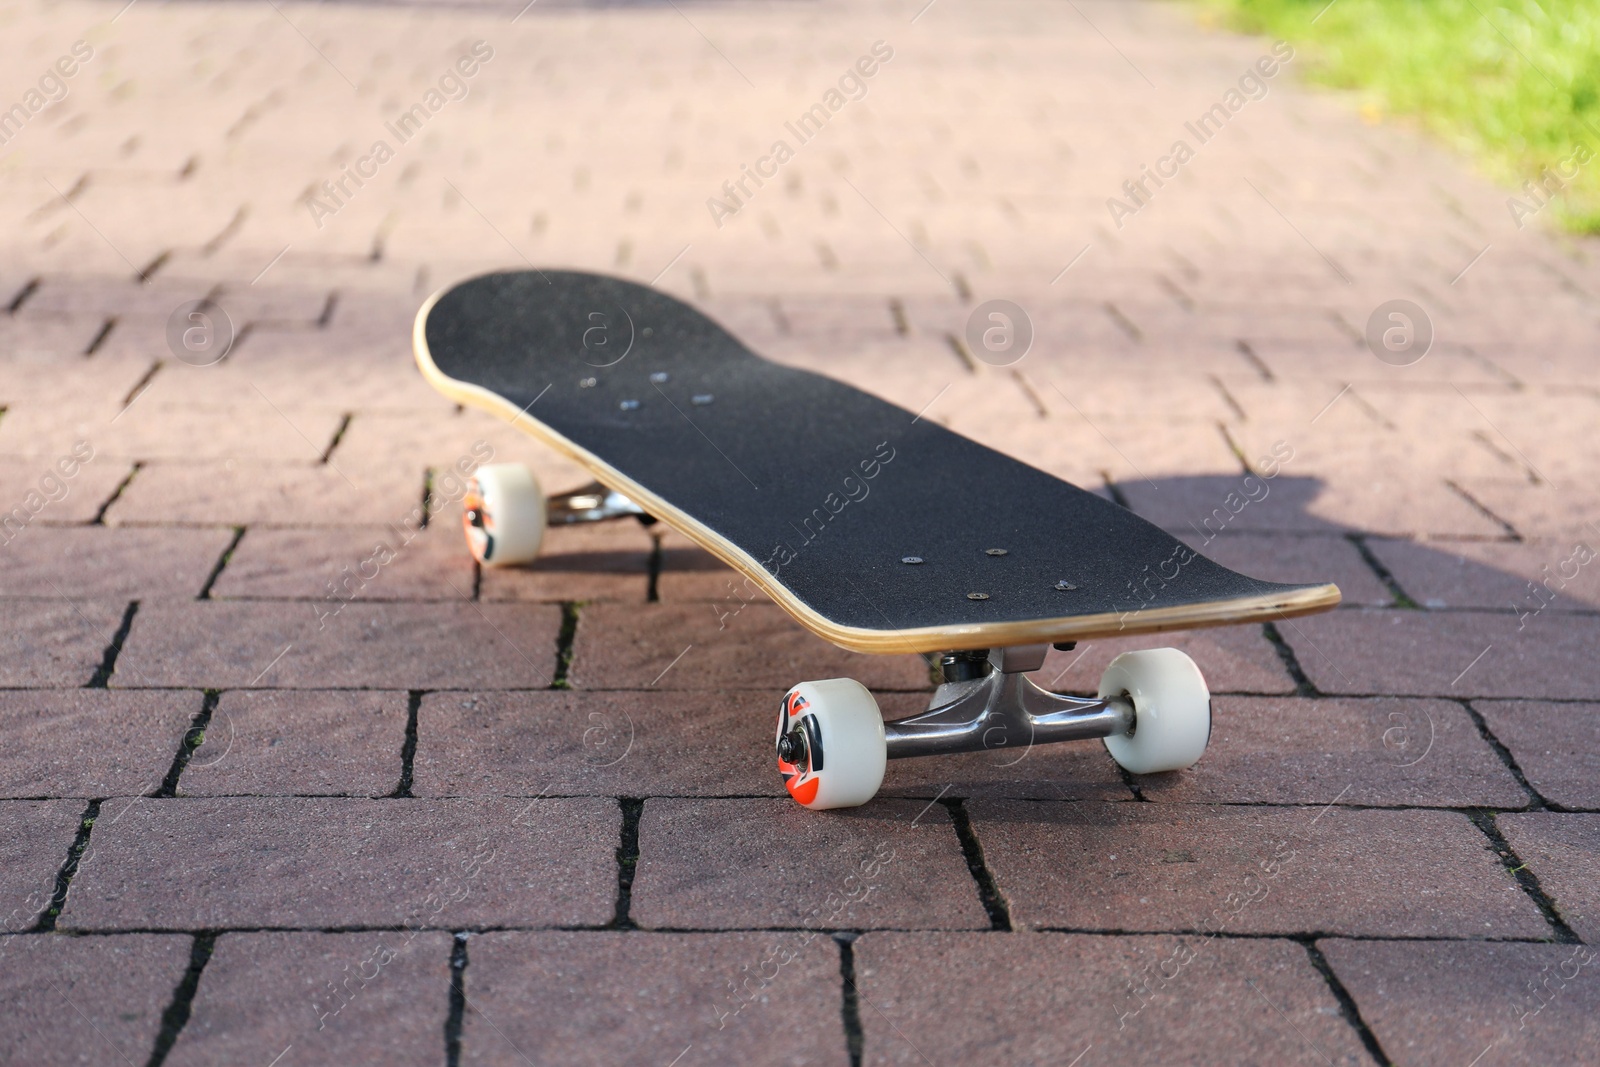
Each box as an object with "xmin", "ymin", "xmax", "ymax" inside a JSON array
[{"xmin": 1200, "ymin": 0, "xmax": 1600, "ymax": 234}]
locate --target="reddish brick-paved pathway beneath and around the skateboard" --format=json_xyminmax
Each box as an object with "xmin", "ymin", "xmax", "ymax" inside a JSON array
[{"xmin": 0, "ymin": 0, "xmax": 1600, "ymax": 1067}]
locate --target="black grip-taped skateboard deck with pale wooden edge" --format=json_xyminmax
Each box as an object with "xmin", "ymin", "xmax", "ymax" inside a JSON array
[{"xmin": 413, "ymin": 270, "xmax": 1339, "ymax": 653}]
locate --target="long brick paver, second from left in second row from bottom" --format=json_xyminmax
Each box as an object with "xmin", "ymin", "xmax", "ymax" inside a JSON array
[{"xmin": 61, "ymin": 798, "xmax": 619, "ymax": 929}]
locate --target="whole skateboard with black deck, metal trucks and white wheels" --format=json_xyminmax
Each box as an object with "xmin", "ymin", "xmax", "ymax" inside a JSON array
[{"xmin": 413, "ymin": 270, "xmax": 1339, "ymax": 809}]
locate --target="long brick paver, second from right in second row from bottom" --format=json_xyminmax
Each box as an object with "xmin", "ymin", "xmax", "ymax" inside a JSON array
[{"xmin": 971, "ymin": 800, "xmax": 1549, "ymax": 937}]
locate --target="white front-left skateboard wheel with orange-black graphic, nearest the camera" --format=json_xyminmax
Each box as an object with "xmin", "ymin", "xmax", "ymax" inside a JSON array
[{"xmin": 778, "ymin": 678, "xmax": 888, "ymax": 811}]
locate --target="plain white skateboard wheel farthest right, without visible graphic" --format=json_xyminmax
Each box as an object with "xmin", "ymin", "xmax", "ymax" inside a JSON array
[{"xmin": 1099, "ymin": 648, "xmax": 1211, "ymax": 774}]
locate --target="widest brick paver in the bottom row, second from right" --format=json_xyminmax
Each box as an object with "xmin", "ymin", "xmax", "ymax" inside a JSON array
[{"xmin": 854, "ymin": 933, "xmax": 1373, "ymax": 1065}]
